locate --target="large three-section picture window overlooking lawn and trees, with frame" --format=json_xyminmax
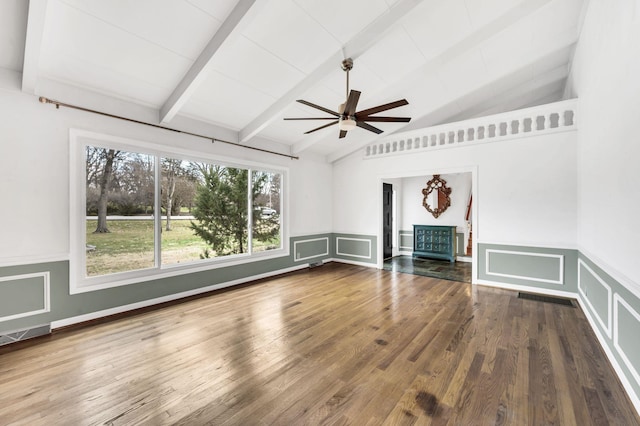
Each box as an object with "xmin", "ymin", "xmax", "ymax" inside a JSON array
[{"xmin": 72, "ymin": 131, "xmax": 286, "ymax": 288}]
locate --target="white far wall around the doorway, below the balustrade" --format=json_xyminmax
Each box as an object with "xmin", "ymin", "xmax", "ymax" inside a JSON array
[{"xmin": 333, "ymin": 131, "xmax": 577, "ymax": 248}]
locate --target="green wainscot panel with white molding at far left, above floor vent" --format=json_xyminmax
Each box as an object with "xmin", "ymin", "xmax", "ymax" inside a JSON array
[{"xmin": 0, "ymin": 272, "xmax": 49, "ymax": 321}]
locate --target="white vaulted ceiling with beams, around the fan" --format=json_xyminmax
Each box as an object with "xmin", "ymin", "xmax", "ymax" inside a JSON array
[{"xmin": 0, "ymin": 0, "xmax": 587, "ymax": 161}]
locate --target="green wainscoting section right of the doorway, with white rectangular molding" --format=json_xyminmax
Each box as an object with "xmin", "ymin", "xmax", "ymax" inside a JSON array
[{"xmin": 478, "ymin": 243, "xmax": 578, "ymax": 293}]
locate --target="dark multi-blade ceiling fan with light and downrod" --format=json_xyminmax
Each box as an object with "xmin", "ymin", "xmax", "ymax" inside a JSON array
[{"xmin": 285, "ymin": 58, "xmax": 411, "ymax": 138}]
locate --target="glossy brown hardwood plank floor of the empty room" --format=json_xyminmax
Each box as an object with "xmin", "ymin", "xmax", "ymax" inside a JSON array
[{"xmin": 0, "ymin": 264, "xmax": 640, "ymax": 425}]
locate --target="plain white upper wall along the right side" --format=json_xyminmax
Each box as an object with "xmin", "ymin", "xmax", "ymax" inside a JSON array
[{"xmin": 568, "ymin": 0, "xmax": 640, "ymax": 289}]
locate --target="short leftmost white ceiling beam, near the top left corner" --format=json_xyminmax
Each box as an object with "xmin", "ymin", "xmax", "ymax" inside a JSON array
[{"xmin": 22, "ymin": 0, "xmax": 47, "ymax": 95}]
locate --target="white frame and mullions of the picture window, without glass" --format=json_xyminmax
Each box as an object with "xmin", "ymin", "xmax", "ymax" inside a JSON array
[{"xmin": 69, "ymin": 128, "xmax": 290, "ymax": 294}]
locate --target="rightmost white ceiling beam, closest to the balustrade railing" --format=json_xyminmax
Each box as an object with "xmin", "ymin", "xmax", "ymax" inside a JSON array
[{"xmin": 327, "ymin": 35, "xmax": 576, "ymax": 163}]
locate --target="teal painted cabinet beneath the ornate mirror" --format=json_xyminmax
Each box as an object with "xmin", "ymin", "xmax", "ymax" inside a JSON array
[{"xmin": 413, "ymin": 225, "xmax": 456, "ymax": 262}]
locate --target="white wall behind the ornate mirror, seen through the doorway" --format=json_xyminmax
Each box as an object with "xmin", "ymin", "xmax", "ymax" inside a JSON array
[{"xmin": 401, "ymin": 172, "xmax": 471, "ymax": 232}]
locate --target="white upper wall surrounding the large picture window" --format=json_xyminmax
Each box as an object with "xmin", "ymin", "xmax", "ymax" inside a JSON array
[{"xmin": 0, "ymin": 70, "xmax": 332, "ymax": 264}]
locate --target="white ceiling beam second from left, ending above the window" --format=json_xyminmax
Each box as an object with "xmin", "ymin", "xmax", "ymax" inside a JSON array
[{"xmin": 160, "ymin": 0, "xmax": 266, "ymax": 123}]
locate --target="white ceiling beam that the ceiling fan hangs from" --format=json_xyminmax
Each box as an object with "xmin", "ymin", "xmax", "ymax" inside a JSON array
[{"xmin": 240, "ymin": 0, "xmax": 428, "ymax": 143}]
